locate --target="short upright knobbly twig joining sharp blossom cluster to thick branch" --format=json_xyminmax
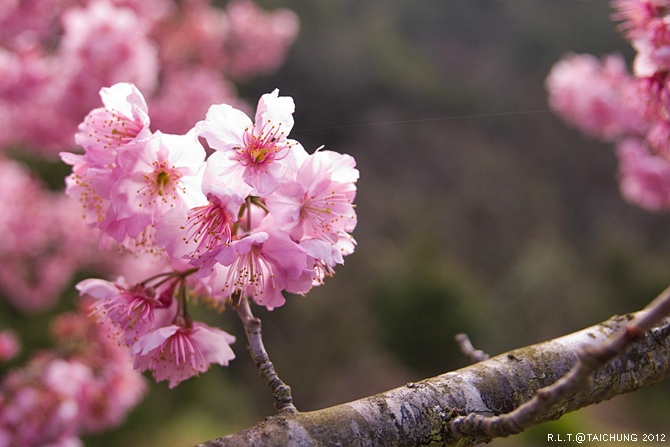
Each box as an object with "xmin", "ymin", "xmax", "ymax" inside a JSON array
[{"xmin": 233, "ymin": 296, "xmax": 298, "ymax": 413}]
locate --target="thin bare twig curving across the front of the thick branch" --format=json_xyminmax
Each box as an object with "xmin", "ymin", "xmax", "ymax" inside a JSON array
[{"xmin": 449, "ymin": 287, "xmax": 670, "ymax": 440}]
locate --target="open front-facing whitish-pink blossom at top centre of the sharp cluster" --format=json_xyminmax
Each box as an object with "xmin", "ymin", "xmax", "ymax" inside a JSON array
[{"xmin": 196, "ymin": 90, "xmax": 304, "ymax": 196}]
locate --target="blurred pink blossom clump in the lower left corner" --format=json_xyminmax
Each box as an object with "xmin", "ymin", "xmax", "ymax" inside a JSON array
[{"xmin": 0, "ymin": 306, "xmax": 146, "ymax": 446}]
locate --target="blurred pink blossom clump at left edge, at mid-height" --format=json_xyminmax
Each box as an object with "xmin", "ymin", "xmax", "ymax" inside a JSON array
[{"xmin": 0, "ymin": 158, "xmax": 95, "ymax": 312}]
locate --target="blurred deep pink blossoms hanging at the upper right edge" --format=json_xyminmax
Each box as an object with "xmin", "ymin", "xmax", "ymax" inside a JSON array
[{"xmin": 546, "ymin": 0, "xmax": 670, "ymax": 211}]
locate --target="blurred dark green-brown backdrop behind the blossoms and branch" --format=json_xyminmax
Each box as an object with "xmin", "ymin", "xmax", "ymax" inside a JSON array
[{"xmin": 46, "ymin": 0, "xmax": 670, "ymax": 447}]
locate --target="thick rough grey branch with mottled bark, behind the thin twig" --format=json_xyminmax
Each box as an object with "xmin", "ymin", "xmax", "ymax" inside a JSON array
[{"xmin": 198, "ymin": 315, "xmax": 670, "ymax": 447}]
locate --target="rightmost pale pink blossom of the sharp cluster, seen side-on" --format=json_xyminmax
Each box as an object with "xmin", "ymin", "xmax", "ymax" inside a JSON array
[{"xmin": 265, "ymin": 151, "xmax": 358, "ymax": 242}]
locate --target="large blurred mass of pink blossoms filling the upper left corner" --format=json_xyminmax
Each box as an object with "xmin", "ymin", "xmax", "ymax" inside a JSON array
[{"xmin": 0, "ymin": 0, "xmax": 299, "ymax": 155}]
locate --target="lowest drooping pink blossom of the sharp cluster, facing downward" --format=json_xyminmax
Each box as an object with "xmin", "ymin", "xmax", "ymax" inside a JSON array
[{"xmin": 130, "ymin": 323, "xmax": 235, "ymax": 388}]
